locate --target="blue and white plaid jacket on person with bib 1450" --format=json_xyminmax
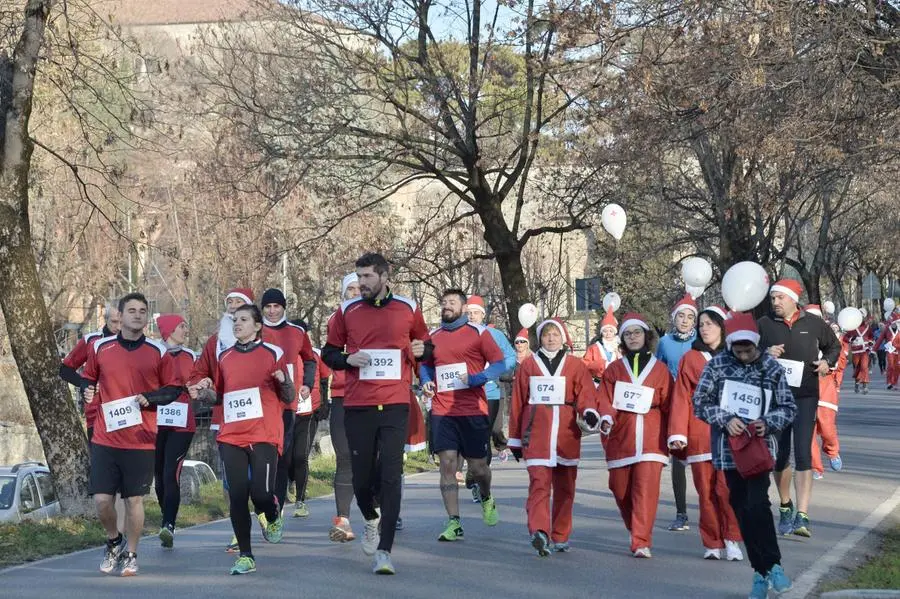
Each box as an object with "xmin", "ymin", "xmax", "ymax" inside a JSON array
[{"xmin": 694, "ymin": 350, "xmax": 797, "ymax": 470}]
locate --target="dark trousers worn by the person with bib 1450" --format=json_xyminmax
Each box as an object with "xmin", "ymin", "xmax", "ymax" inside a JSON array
[{"xmin": 725, "ymin": 470, "xmax": 781, "ymax": 576}]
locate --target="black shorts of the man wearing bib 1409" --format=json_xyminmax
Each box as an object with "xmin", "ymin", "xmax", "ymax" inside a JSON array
[{"xmin": 90, "ymin": 443, "xmax": 156, "ymax": 497}]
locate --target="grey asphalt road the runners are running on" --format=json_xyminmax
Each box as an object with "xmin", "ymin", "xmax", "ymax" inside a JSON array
[{"xmin": 0, "ymin": 373, "xmax": 900, "ymax": 599}]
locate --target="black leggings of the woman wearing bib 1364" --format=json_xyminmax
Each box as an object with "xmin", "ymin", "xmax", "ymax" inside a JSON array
[{"xmin": 219, "ymin": 443, "xmax": 279, "ymax": 555}]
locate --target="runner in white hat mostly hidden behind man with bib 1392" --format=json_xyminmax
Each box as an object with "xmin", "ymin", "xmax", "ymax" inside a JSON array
[{"xmin": 323, "ymin": 272, "xmax": 359, "ymax": 543}]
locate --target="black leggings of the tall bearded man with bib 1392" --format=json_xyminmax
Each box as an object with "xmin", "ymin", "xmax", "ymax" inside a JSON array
[{"xmin": 344, "ymin": 403, "xmax": 409, "ymax": 552}]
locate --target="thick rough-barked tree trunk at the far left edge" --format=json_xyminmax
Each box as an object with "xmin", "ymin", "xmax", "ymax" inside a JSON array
[{"xmin": 0, "ymin": 0, "xmax": 89, "ymax": 514}]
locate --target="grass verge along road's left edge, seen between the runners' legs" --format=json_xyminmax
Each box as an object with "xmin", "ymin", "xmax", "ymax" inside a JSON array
[{"xmin": 0, "ymin": 452, "xmax": 434, "ymax": 567}]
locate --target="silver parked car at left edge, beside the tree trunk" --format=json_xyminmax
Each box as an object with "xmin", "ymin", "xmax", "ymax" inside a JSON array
[{"xmin": 0, "ymin": 462, "xmax": 60, "ymax": 522}]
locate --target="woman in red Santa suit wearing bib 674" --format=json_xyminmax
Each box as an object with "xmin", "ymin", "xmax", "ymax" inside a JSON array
[{"xmin": 509, "ymin": 319, "xmax": 612, "ymax": 557}]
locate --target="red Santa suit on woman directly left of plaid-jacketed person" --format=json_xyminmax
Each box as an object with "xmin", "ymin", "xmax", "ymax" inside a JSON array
[{"xmin": 668, "ymin": 349, "xmax": 741, "ymax": 549}]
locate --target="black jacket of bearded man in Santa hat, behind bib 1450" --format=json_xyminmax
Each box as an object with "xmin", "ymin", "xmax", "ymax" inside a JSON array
[{"xmin": 757, "ymin": 311, "xmax": 841, "ymax": 399}]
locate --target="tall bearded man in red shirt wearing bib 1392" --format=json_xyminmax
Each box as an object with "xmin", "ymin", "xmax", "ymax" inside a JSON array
[{"xmin": 322, "ymin": 253, "xmax": 430, "ymax": 574}]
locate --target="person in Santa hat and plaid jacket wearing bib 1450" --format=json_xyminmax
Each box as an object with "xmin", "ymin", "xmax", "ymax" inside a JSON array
[{"xmin": 694, "ymin": 312, "xmax": 800, "ymax": 599}]
